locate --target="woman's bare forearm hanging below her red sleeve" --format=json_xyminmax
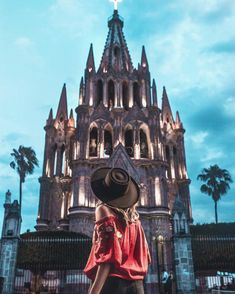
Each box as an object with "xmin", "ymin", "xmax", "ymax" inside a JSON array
[{"xmin": 88, "ymin": 263, "xmax": 111, "ymax": 294}]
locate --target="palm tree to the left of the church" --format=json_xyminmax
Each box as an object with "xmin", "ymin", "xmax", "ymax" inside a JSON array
[{"xmin": 10, "ymin": 145, "xmax": 38, "ymax": 210}]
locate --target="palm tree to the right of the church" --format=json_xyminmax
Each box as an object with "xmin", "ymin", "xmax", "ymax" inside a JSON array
[{"xmin": 197, "ymin": 164, "xmax": 232, "ymax": 223}]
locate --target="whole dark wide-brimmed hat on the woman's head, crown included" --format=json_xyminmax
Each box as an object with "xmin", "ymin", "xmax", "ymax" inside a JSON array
[{"xmin": 91, "ymin": 167, "xmax": 140, "ymax": 208}]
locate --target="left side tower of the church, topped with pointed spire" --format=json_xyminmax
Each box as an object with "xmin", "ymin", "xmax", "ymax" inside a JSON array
[{"xmin": 36, "ymin": 84, "xmax": 75, "ymax": 230}]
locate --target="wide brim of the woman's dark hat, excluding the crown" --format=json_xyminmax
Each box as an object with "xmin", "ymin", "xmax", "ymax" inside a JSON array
[{"xmin": 91, "ymin": 167, "xmax": 140, "ymax": 208}]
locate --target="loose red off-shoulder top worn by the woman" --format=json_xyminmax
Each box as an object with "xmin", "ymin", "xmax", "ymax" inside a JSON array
[{"xmin": 84, "ymin": 216, "xmax": 150, "ymax": 280}]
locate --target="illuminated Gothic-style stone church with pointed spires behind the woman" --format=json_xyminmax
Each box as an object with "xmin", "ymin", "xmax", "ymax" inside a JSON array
[{"xmin": 36, "ymin": 10, "xmax": 193, "ymax": 293}]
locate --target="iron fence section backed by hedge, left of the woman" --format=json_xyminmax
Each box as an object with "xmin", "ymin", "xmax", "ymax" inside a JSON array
[{"xmin": 14, "ymin": 231, "xmax": 91, "ymax": 294}]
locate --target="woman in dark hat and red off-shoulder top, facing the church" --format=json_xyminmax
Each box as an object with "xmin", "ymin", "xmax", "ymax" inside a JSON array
[{"xmin": 84, "ymin": 167, "xmax": 150, "ymax": 294}]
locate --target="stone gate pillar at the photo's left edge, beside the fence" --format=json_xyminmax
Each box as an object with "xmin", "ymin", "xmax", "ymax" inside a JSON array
[{"xmin": 0, "ymin": 194, "xmax": 21, "ymax": 294}]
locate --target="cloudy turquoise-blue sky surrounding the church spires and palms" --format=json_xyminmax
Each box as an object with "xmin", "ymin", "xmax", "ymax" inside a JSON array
[{"xmin": 0, "ymin": 0, "xmax": 235, "ymax": 231}]
